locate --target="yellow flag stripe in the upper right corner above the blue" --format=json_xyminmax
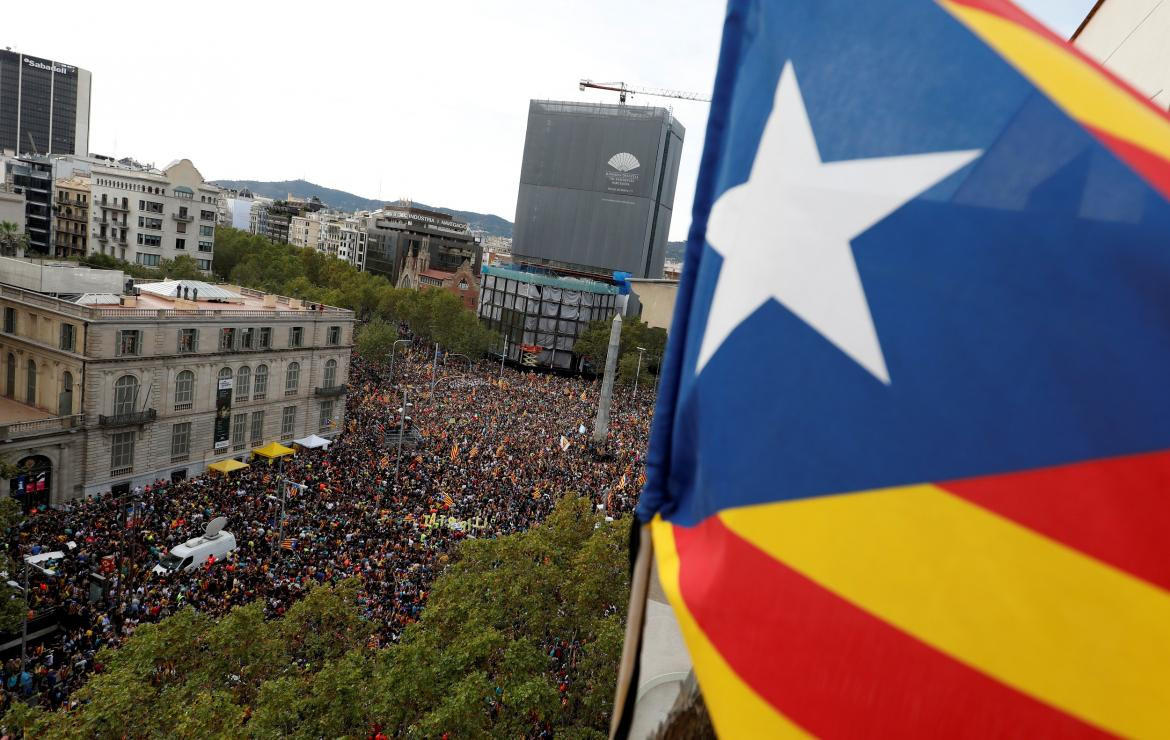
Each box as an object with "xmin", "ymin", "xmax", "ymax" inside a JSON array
[{"xmin": 940, "ymin": 0, "xmax": 1170, "ymax": 159}]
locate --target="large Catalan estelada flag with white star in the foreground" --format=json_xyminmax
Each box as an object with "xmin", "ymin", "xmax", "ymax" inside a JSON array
[{"xmin": 638, "ymin": 0, "xmax": 1170, "ymax": 738}]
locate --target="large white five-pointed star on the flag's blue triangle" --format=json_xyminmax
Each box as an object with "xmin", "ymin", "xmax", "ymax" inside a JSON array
[{"xmin": 695, "ymin": 62, "xmax": 980, "ymax": 384}]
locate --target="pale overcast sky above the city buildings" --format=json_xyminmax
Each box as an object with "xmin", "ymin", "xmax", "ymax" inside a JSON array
[{"xmin": 0, "ymin": 0, "xmax": 1092, "ymax": 239}]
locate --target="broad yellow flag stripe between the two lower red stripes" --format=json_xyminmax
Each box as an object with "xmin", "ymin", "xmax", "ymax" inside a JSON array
[{"xmin": 720, "ymin": 485, "xmax": 1170, "ymax": 736}]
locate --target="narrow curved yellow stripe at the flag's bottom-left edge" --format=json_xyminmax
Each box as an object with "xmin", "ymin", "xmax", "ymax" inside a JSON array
[{"xmin": 651, "ymin": 516, "xmax": 810, "ymax": 738}]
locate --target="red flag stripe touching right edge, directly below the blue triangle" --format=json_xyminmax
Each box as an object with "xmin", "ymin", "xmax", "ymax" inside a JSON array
[{"xmin": 938, "ymin": 452, "xmax": 1170, "ymax": 589}]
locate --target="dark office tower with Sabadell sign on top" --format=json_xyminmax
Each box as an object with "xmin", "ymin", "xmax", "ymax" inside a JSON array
[{"xmin": 0, "ymin": 50, "xmax": 91, "ymax": 155}]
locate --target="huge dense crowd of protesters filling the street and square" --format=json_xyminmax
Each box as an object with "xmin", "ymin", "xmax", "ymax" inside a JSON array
[{"xmin": 0, "ymin": 348, "xmax": 653, "ymax": 708}]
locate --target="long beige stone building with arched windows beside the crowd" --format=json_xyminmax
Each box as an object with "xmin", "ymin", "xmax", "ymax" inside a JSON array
[{"xmin": 0, "ymin": 269, "xmax": 353, "ymax": 503}]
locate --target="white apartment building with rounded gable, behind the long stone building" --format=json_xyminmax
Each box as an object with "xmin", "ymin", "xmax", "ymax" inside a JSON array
[{"xmin": 89, "ymin": 159, "xmax": 219, "ymax": 270}]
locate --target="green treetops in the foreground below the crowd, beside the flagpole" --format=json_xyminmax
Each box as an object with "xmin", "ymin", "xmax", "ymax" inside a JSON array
[{"xmin": 4, "ymin": 496, "xmax": 629, "ymax": 738}]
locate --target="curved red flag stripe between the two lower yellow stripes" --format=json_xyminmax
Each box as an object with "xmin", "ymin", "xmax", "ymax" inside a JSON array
[{"xmin": 674, "ymin": 518, "xmax": 1103, "ymax": 738}]
